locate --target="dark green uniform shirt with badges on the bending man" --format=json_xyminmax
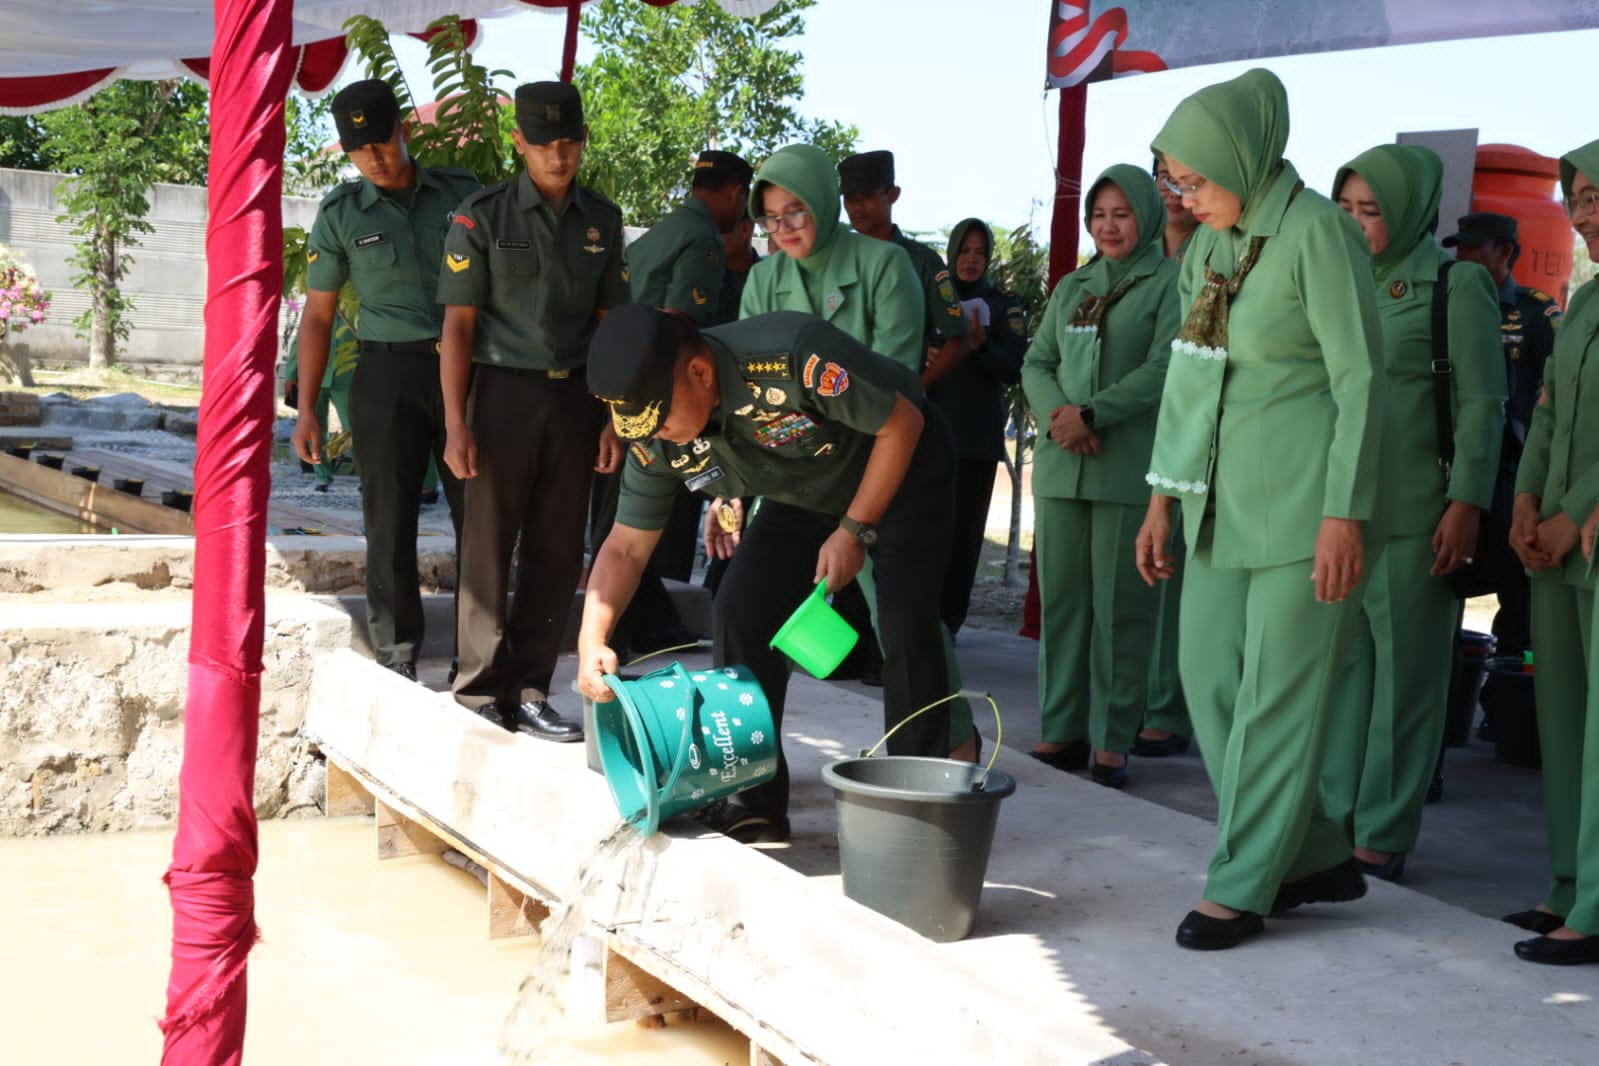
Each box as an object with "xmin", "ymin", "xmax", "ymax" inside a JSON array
[{"xmin": 616, "ymin": 312, "xmax": 923, "ymax": 529}]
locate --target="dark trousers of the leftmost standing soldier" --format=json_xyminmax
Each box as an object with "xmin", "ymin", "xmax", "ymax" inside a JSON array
[{"xmin": 350, "ymin": 352, "xmax": 462, "ymax": 666}]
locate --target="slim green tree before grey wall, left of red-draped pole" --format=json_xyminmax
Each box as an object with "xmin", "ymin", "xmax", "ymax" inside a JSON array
[{"xmin": 40, "ymin": 78, "xmax": 211, "ymax": 366}]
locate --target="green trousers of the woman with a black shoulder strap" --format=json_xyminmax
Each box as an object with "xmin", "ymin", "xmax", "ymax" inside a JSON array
[{"xmin": 1321, "ymin": 534, "xmax": 1460, "ymax": 852}]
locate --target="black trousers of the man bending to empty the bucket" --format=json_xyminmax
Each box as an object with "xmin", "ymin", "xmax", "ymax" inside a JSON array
[{"xmin": 712, "ymin": 412, "xmax": 953, "ymax": 817}]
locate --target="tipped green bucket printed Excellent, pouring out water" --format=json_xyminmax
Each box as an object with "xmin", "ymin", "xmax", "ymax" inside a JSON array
[{"xmin": 593, "ymin": 663, "xmax": 777, "ymax": 836}]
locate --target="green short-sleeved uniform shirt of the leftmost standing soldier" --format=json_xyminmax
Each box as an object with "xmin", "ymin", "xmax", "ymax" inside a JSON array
[{"xmin": 305, "ymin": 166, "xmax": 483, "ymax": 342}]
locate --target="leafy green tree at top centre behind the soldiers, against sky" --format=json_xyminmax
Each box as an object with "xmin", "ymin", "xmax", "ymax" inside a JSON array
[{"xmin": 572, "ymin": 0, "xmax": 859, "ymax": 225}]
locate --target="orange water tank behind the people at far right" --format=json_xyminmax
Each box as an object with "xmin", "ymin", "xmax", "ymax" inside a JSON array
[{"xmin": 1471, "ymin": 144, "xmax": 1577, "ymax": 307}]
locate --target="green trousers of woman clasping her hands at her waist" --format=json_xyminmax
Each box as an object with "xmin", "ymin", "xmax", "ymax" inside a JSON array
[{"xmin": 1033, "ymin": 495, "xmax": 1159, "ymax": 753}]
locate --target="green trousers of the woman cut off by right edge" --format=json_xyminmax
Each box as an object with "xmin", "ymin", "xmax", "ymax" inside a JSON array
[{"xmin": 1532, "ymin": 575, "xmax": 1599, "ymax": 933}]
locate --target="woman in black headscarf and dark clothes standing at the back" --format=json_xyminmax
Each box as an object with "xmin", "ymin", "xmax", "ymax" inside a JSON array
[{"xmin": 927, "ymin": 219, "xmax": 1027, "ymax": 636}]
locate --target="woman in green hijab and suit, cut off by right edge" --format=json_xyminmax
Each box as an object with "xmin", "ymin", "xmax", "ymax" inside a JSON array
[{"xmin": 1505, "ymin": 141, "xmax": 1599, "ymax": 965}]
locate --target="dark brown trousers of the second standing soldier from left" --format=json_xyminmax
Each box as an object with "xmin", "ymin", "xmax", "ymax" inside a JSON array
[{"xmin": 454, "ymin": 366, "xmax": 604, "ymax": 708}]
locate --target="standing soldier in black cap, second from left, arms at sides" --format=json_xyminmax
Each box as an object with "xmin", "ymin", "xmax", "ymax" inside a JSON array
[{"xmin": 438, "ymin": 82, "xmax": 627, "ymax": 742}]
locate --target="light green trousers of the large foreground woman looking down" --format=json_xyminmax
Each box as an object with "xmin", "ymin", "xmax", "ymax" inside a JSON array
[{"xmin": 1178, "ymin": 556, "xmax": 1362, "ymax": 914}]
